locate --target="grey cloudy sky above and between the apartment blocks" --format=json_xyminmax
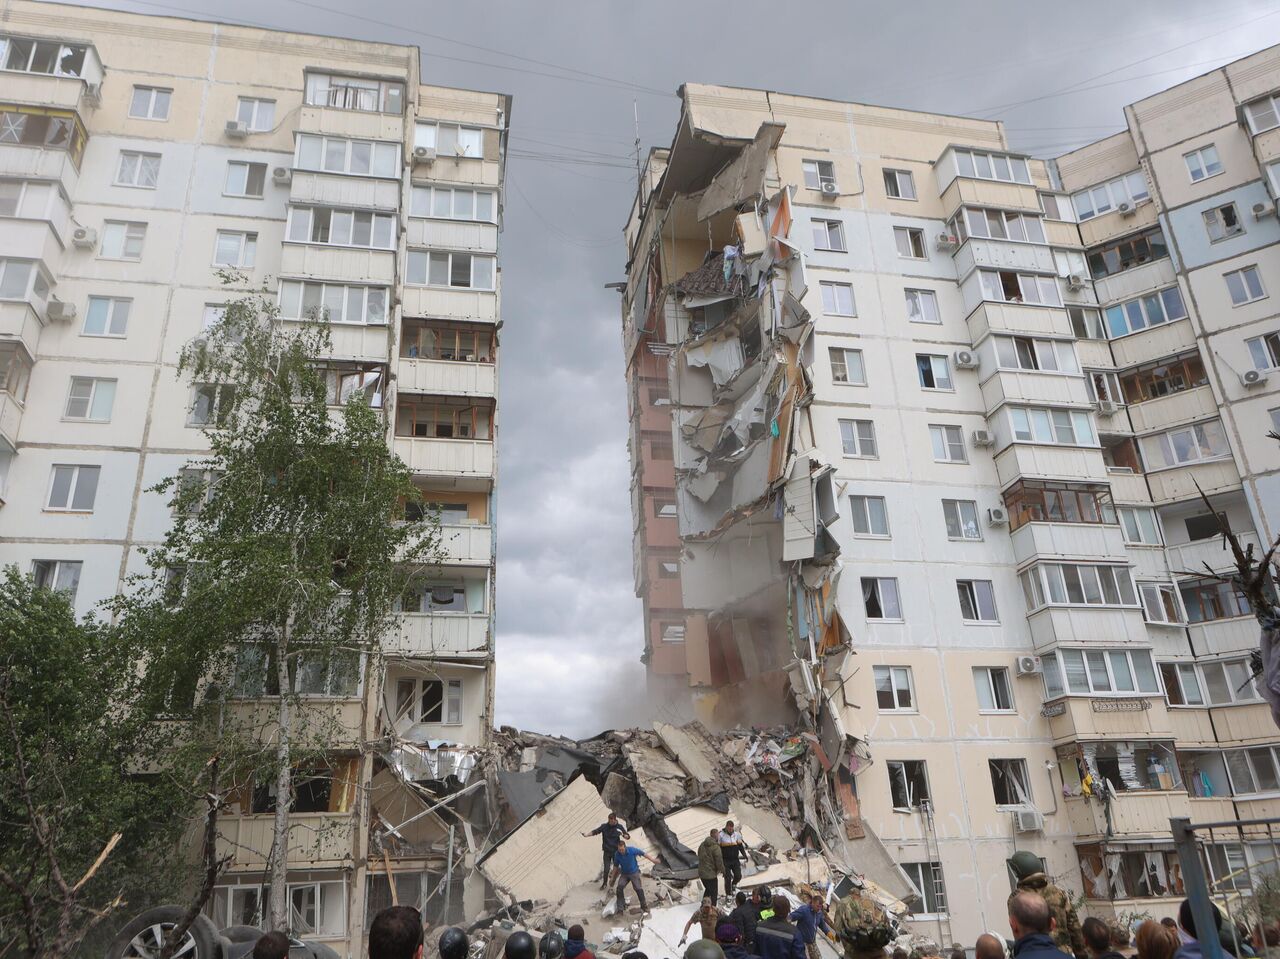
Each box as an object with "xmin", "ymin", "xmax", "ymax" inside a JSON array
[{"xmin": 80, "ymin": 0, "xmax": 1280, "ymax": 735}]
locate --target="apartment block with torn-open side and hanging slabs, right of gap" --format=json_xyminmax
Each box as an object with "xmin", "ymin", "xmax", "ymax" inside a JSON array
[{"xmin": 622, "ymin": 47, "xmax": 1280, "ymax": 944}]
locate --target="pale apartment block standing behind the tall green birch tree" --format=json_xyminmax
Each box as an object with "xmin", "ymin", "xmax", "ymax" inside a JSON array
[{"xmin": 0, "ymin": 0, "xmax": 511, "ymax": 955}]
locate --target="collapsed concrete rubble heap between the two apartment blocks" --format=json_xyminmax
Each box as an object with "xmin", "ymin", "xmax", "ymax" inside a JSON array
[{"xmin": 397, "ymin": 722, "xmax": 914, "ymax": 959}]
